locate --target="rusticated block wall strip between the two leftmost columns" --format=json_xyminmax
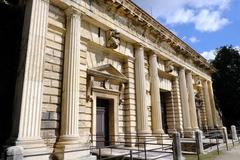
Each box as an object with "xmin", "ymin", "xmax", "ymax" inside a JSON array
[{"xmin": 41, "ymin": 5, "xmax": 65, "ymax": 147}]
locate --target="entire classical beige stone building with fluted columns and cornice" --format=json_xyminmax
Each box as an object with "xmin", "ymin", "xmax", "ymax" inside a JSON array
[{"xmin": 2, "ymin": 0, "xmax": 221, "ymax": 159}]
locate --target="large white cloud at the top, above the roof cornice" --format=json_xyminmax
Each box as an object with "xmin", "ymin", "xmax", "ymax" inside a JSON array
[{"xmin": 134, "ymin": 0, "xmax": 232, "ymax": 32}]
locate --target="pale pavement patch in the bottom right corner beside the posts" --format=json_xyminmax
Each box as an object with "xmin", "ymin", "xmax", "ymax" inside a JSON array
[{"xmin": 214, "ymin": 145, "xmax": 240, "ymax": 160}]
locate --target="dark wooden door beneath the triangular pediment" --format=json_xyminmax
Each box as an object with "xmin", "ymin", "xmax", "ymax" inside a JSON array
[{"xmin": 96, "ymin": 99, "xmax": 109, "ymax": 147}]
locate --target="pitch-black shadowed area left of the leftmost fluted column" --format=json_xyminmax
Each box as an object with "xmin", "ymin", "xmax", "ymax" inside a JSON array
[{"xmin": 0, "ymin": 1, "xmax": 23, "ymax": 152}]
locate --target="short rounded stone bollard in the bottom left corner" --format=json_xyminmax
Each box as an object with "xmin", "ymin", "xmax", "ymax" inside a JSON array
[{"xmin": 6, "ymin": 146, "xmax": 23, "ymax": 160}]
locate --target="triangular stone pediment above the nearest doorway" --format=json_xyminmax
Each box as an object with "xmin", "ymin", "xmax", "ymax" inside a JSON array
[{"xmin": 88, "ymin": 64, "xmax": 128, "ymax": 82}]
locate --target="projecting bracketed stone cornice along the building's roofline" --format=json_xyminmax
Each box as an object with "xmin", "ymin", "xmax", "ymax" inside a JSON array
[{"xmin": 105, "ymin": 0, "xmax": 215, "ymax": 73}]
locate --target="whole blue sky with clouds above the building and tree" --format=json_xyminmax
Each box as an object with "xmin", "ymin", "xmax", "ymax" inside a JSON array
[{"xmin": 133, "ymin": 0, "xmax": 240, "ymax": 59}]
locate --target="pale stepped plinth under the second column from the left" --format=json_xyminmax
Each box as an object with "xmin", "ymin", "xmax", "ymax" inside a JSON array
[{"xmin": 54, "ymin": 144, "xmax": 90, "ymax": 160}]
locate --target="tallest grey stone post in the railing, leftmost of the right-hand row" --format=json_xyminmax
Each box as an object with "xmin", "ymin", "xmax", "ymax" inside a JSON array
[{"xmin": 173, "ymin": 132, "xmax": 182, "ymax": 160}]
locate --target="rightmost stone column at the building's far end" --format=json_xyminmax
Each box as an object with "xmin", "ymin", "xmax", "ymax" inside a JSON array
[{"xmin": 208, "ymin": 82, "xmax": 218, "ymax": 127}]
